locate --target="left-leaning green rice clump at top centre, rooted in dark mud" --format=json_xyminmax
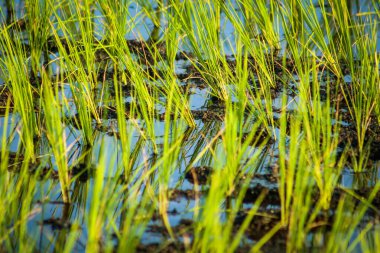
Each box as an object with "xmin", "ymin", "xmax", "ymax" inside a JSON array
[{"xmin": 171, "ymin": 1, "xmax": 231, "ymax": 101}]
